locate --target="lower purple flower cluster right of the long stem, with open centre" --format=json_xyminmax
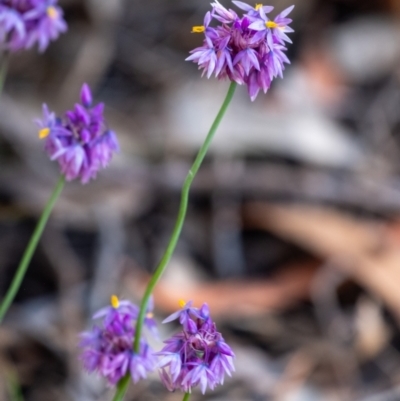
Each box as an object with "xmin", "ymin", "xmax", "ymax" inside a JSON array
[{"xmin": 157, "ymin": 301, "xmax": 234, "ymax": 394}]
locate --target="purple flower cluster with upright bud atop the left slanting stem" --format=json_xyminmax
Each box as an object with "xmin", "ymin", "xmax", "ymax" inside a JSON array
[{"xmin": 36, "ymin": 84, "xmax": 119, "ymax": 184}]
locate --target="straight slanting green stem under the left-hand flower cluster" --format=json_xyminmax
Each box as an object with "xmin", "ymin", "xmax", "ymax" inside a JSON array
[{"xmin": 0, "ymin": 176, "xmax": 65, "ymax": 323}]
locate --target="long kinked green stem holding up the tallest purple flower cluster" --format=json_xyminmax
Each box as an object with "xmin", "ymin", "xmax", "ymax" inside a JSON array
[{"xmin": 134, "ymin": 82, "xmax": 236, "ymax": 353}]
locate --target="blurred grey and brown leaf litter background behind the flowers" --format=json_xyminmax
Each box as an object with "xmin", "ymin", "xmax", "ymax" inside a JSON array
[{"xmin": 0, "ymin": 0, "xmax": 400, "ymax": 401}]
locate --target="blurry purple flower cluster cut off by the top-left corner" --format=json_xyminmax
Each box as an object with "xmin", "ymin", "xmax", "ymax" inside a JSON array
[{"xmin": 0, "ymin": 0, "xmax": 67, "ymax": 52}]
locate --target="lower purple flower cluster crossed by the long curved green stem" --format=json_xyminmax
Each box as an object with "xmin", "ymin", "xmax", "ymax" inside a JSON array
[{"xmin": 80, "ymin": 295, "xmax": 157, "ymax": 386}]
